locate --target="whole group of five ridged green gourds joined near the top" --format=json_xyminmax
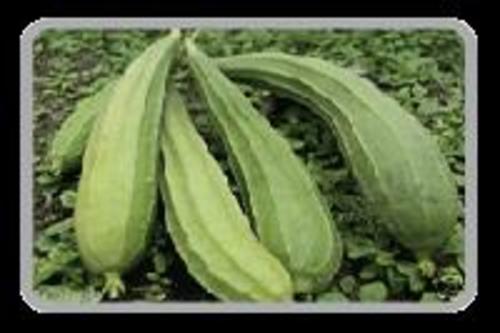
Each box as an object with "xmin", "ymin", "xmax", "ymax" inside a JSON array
[{"xmin": 35, "ymin": 31, "xmax": 460, "ymax": 301}]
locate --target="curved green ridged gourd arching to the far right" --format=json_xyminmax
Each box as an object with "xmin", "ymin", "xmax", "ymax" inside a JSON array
[{"xmin": 218, "ymin": 53, "xmax": 458, "ymax": 260}]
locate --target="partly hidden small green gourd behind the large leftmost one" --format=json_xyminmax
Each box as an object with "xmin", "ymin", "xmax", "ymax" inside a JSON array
[{"xmin": 48, "ymin": 81, "xmax": 115, "ymax": 176}]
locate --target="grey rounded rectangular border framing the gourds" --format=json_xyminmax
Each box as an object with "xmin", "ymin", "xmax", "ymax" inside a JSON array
[{"xmin": 20, "ymin": 18, "xmax": 477, "ymax": 313}]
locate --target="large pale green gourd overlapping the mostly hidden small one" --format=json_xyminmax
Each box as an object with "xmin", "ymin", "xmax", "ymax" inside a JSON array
[{"xmin": 75, "ymin": 31, "xmax": 180, "ymax": 297}]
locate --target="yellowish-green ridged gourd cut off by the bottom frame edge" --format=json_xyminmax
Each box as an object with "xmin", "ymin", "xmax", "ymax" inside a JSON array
[{"xmin": 160, "ymin": 85, "xmax": 292, "ymax": 301}]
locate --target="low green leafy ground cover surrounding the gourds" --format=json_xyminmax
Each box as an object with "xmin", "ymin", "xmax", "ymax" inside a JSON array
[{"xmin": 33, "ymin": 30, "xmax": 465, "ymax": 302}]
